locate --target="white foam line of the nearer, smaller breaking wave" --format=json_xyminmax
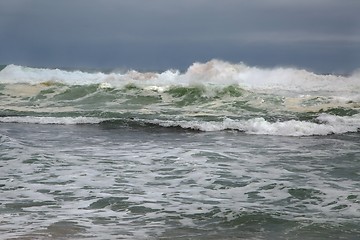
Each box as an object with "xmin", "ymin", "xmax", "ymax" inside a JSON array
[{"xmin": 0, "ymin": 114, "xmax": 360, "ymax": 136}]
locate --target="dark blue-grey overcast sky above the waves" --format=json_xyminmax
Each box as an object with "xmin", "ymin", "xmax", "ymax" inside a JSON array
[{"xmin": 0, "ymin": 0, "xmax": 360, "ymax": 73}]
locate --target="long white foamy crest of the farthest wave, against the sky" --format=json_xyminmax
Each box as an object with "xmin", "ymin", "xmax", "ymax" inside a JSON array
[{"xmin": 0, "ymin": 60, "xmax": 360, "ymax": 96}]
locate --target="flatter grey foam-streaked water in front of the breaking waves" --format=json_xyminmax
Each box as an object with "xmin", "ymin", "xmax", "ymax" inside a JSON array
[{"xmin": 0, "ymin": 124, "xmax": 360, "ymax": 239}]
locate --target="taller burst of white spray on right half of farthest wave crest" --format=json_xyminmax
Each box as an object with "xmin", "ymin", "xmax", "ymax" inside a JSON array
[{"xmin": 185, "ymin": 60, "xmax": 360, "ymax": 93}]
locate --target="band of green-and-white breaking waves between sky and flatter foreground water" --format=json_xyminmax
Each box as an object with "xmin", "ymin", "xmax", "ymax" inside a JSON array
[{"xmin": 0, "ymin": 60, "xmax": 360, "ymax": 136}]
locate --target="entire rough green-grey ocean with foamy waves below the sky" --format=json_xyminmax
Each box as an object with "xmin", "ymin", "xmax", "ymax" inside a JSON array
[{"xmin": 0, "ymin": 60, "xmax": 360, "ymax": 240}]
